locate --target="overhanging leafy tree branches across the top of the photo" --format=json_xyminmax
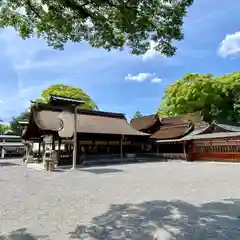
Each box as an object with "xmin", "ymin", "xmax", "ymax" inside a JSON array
[{"xmin": 0, "ymin": 0, "xmax": 194, "ymax": 56}]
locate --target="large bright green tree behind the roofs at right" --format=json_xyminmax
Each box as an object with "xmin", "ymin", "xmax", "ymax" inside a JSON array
[{"xmin": 158, "ymin": 72, "xmax": 240, "ymax": 124}]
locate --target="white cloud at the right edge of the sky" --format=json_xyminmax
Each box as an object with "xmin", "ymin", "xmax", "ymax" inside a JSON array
[{"xmin": 218, "ymin": 32, "xmax": 240, "ymax": 58}]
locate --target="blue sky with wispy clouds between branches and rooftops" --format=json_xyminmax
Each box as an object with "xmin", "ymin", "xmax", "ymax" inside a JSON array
[{"xmin": 0, "ymin": 0, "xmax": 240, "ymax": 121}]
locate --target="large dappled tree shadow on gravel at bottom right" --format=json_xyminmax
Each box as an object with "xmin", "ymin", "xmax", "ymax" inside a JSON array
[{"xmin": 69, "ymin": 199, "xmax": 240, "ymax": 240}]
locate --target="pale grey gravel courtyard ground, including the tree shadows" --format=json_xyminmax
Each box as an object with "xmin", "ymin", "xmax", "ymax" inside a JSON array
[{"xmin": 0, "ymin": 159, "xmax": 240, "ymax": 240}]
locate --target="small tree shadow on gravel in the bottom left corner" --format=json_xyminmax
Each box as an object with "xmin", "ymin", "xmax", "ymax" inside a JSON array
[{"xmin": 0, "ymin": 228, "xmax": 49, "ymax": 240}]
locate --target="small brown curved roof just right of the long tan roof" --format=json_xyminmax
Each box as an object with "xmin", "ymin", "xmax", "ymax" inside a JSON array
[{"xmin": 130, "ymin": 114, "xmax": 159, "ymax": 131}]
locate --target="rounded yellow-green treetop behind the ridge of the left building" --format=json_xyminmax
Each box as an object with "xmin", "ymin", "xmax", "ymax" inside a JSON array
[{"xmin": 35, "ymin": 84, "xmax": 98, "ymax": 110}]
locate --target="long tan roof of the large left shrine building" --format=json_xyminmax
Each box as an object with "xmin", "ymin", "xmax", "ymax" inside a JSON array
[{"xmin": 23, "ymin": 104, "xmax": 149, "ymax": 139}]
